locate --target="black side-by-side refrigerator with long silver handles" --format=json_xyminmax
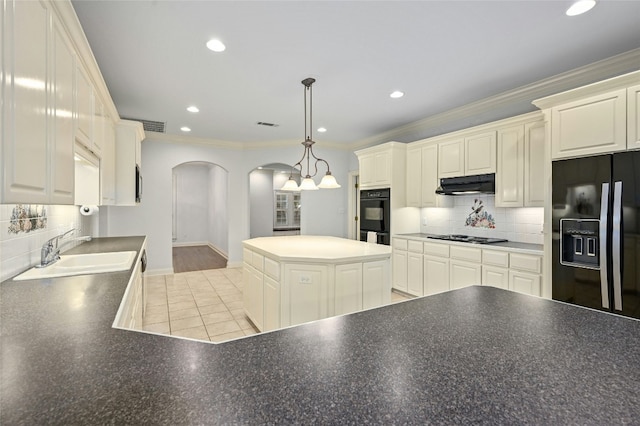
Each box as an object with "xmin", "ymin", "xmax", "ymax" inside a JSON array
[{"xmin": 552, "ymin": 152, "xmax": 640, "ymax": 318}]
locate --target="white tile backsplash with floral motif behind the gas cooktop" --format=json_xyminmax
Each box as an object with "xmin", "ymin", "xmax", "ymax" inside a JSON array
[{"xmin": 420, "ymin": 194, "xmax": 544, "ymax": 244}]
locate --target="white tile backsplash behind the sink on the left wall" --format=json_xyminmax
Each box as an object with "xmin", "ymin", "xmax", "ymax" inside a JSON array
[{"xmin": 0, "ymin": 204, "xmax": 92, "ymax": 281}]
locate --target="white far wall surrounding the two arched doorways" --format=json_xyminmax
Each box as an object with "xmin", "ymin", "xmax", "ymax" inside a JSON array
[{"xmin": 106, "ymin": 138, "xmax": 351, "ymax": 273}]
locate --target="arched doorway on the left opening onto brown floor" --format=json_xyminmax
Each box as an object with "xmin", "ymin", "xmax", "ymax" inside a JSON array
[{"xmin": 172, "ymin": 161, "xmax": 229, "ymax": 272}]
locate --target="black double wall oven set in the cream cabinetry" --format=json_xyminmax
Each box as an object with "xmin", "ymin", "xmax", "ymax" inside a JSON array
[{"xmin": 360, "ymin": 188, "xmax": 391, "ymax": 245}]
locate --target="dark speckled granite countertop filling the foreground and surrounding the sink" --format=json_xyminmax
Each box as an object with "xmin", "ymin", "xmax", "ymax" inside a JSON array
[{"xmin": 0, "ymin": 235, "xmax": 640, "ymax": 425}]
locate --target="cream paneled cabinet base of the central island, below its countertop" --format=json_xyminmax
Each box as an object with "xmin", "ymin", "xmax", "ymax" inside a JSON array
[{"xmin": 243, "ymin": 248, "xmax": 391, "ymax": 331}]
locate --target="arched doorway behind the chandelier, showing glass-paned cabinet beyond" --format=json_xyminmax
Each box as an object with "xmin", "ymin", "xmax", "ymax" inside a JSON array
[{"xmin": 249, "ymin": 163, "xmax": 302, "ymax": 238}]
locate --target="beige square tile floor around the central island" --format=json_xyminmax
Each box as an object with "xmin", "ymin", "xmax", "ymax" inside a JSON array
[{"xmin": 142, "ymin": 268, "xmax": 408, "ymax": 343}]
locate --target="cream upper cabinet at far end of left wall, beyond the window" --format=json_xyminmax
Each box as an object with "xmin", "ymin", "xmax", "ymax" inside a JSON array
[{"xmin": 116, "ymin": 120, "xmax": 145, "ymax": 206}]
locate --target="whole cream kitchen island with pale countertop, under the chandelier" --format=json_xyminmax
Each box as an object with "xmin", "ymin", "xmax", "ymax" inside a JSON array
[{"xmin": 243, "ymin": 235, "xmax": 391, "ymax": 331}]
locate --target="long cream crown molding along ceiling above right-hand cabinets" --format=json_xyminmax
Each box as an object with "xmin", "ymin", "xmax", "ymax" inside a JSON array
[{"xmin": 349, "ymin": 48, "xmax": 640, "ymax": 150}]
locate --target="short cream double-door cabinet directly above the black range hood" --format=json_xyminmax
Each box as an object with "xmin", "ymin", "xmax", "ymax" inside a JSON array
[{"xmin": 438, "ymin": 131, "xmax": 496, "ymax": 178}]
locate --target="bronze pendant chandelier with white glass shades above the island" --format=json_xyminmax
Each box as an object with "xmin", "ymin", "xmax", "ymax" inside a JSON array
[{"xmin": 281, "ymin": 78, "xmax": 340, "ymax": 191}]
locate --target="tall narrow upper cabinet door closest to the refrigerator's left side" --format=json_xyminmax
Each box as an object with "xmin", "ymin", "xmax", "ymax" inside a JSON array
[{"xmin": 524, "ymin": 121, "xmax": 546, "ymax": 207}]
